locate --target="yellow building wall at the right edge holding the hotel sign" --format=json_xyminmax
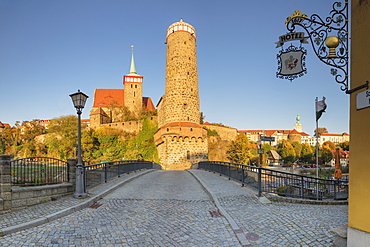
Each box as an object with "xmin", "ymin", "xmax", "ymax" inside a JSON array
[{"xmin": 347, "ymin": 0, "xmax": 370, "ymax": 246}]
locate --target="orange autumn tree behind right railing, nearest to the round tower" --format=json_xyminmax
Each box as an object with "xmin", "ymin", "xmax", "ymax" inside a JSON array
[{"xmin": 226, "ymin": 134, "xmax": 251, "ymax": 164}]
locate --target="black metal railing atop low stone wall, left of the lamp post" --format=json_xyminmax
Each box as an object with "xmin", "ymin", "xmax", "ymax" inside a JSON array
[{"xmin": 10, "ymin": 157, "xmax": 69, "ymax": 186}]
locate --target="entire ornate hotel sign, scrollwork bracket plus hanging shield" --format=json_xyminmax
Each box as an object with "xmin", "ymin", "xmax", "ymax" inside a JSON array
[{"xmin": 275, "ymin": 3, "xmax": 354, "ymax": 94}]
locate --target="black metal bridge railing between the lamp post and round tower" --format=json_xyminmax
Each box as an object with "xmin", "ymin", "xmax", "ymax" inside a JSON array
[{"xmin": 84, "ymin": 160, "xmax": 160, "ymax": 188}]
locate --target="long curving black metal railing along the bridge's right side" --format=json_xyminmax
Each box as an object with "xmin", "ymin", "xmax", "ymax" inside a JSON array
[{"xmin": 198, "ymin": 161, "xmax": 348, "ymax": 200}]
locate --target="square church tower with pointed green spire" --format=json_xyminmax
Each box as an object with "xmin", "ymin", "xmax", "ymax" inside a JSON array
[{"xmin": 123, "ymin": 46, "xmax": 144, "ymax": 115}]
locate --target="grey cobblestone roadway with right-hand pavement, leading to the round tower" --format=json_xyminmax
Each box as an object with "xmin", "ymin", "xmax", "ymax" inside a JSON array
[{"xmin": 0, "ymin": 170, "xmax": 347, "ymax": 246}]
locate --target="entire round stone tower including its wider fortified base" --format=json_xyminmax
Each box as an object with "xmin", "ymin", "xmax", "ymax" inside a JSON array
[{"xmin": 154, "ymin": 20, "xmax": 208, "ymax": 170}]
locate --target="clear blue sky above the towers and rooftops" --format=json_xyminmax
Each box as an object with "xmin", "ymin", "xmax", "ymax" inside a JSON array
[{"xmin": 0, "ymin": 0, "xmax": 349, "ymax": 135}]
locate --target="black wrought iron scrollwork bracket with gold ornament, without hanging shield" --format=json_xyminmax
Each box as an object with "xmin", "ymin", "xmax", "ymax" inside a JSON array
[{"xmin": 277, "ymin": 0, "xmax": 352, "ymax": 93}]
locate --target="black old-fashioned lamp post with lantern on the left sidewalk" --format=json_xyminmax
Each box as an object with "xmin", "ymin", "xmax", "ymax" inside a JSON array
[{"xmin": 69, "ymin": 90, "xmax": 89, "ymax": 198}]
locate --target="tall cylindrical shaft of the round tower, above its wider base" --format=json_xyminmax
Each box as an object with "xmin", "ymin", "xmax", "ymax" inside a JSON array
[{"xmin": 160, "ymin": 20, "xmax": 200, "ymax": 126}]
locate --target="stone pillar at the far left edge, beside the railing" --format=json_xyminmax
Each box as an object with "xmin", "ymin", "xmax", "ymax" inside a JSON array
[{"xmin": 0, "ymin": 154, "xmax": 12, "ymax": 211}]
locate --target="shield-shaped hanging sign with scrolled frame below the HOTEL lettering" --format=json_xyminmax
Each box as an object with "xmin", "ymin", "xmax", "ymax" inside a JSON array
[{"xmin": 276, "ymin": 45, "xmax": 307, "ymax": 81}]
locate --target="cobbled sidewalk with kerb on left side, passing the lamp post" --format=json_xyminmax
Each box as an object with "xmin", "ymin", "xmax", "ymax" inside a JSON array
[{"xmin": 0, "ymin": 170, "xmax": 153, "ymax": 235}]
